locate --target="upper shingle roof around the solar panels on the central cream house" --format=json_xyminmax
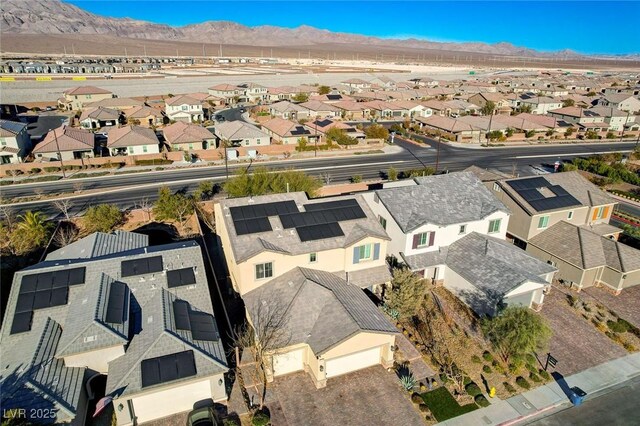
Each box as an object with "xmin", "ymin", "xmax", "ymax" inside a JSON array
[{"xmin": 220, "ymin": 192, "xmax": 389, "ymax": 263}]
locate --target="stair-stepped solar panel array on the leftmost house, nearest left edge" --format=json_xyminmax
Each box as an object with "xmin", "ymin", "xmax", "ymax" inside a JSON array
[{"xmin": 10, "ymin": 267, "xmax": 86, "ymax": 334}]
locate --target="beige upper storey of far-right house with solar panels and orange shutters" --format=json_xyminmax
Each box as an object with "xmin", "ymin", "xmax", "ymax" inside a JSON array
[{"xmin": 492, "ymin": 171, "xmax": 616, "ymax": 248}]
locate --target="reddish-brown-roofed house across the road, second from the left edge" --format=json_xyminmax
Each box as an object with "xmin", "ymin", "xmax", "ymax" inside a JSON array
[{"xmin": 33, "ymin": 126, "xmax": 96, "ymax": 161}]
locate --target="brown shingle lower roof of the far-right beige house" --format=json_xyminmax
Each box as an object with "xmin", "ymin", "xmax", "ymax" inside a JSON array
[{"xmin": 529, "ymin": 221, "xmax": 640, "ymax": 272}]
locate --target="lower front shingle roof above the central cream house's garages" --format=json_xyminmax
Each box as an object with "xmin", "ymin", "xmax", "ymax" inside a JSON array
[{"xmin": 244, "ymin": 267, "xmax": 397, "ymax": 355}]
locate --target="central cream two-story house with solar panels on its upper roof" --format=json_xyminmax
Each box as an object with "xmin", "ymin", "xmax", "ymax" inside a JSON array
[{"xmin": 214, "ymin": 192, "xmax": 396, "ymax": 387}]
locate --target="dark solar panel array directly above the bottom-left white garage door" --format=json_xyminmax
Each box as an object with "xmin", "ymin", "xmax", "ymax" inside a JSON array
[{"xmin": 140, "ymin": 350, "xmax": 196, "ymax": 388}]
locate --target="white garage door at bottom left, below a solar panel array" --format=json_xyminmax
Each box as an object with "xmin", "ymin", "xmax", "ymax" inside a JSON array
[{"xmin": 132, "ymin": 380, "xmax": 211, "ymax": 423}]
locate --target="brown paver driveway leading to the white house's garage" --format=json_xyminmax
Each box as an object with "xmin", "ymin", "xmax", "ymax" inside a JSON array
[{"xmin": 540, "ymin": 288, "xmax": 627, "ymax": 376}]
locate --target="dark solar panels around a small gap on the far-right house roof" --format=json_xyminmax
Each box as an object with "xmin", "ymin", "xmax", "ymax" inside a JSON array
[{"xmin": 508, "ymin": 177, "xmax": 581, "ymax": 212}]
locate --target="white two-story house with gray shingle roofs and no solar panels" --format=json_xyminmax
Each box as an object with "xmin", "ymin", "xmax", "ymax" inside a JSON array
[{"xmin": 364, "ymin": 172, "xmax": 555, "ymax": 315}]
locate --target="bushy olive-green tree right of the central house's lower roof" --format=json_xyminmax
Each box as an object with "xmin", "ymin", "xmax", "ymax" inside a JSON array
[{"xmin": 385, "ymin": 268, "xmax": 428, "ymax": 319}]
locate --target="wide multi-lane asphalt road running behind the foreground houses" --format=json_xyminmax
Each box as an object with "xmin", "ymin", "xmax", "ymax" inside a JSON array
[{"xmin": 1, "ymin": 138, "xmax": 634, "ymax": 220}]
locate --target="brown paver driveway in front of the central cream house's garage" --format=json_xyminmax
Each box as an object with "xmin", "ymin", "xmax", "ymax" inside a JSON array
[{"xmin": 268, "ymin": 365, "xmax": 424, "ymax": 426}]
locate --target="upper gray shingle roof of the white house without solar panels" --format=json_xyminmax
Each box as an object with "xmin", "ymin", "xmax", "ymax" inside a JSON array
[{"xmin": 376, "ymin": 172, "xmax": 509, "ymax": 233}]
